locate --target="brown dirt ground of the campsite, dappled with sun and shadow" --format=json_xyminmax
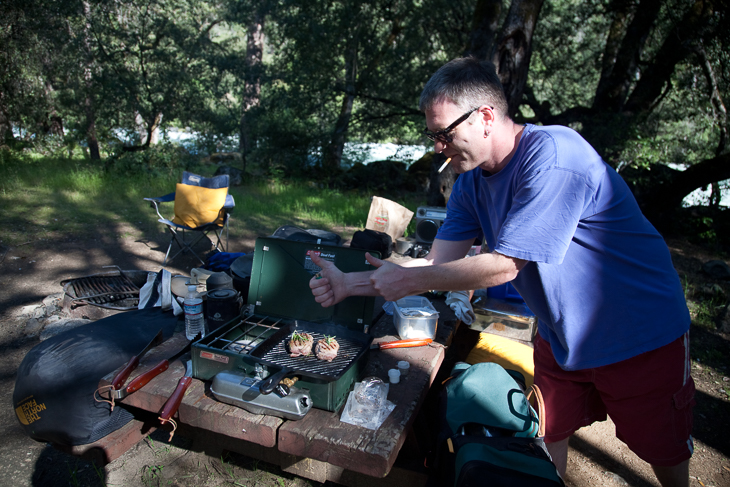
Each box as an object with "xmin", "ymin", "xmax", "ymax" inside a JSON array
[{"xmin": 0, "ymin": 230, "xmax": 730, "ymax": 487}]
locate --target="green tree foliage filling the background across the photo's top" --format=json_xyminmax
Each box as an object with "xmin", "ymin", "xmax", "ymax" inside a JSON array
[{"xmin": 0, "ymin": 0, "xmax": 730, "ymax": 210}]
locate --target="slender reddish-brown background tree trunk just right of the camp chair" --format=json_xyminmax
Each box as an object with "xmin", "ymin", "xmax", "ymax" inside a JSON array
[{"xmin": 238, "ymin": 11, "xmax": 264, "ymax": 173}]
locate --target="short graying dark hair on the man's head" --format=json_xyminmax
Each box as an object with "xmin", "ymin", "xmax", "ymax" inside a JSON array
[{"xmin": 418, "ymin": 57, "xmax": 508, "ymax": 117}]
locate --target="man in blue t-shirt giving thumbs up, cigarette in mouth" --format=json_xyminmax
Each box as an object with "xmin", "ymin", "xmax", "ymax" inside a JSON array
[{"xmin": 310, "ymin": 58, "xmax": 694, "ymax": 486}]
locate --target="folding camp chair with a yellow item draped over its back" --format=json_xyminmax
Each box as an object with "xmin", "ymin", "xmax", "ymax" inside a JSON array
[{"xmin": 145, "ymin": 171, "xmax": 236, "ymax": 267}]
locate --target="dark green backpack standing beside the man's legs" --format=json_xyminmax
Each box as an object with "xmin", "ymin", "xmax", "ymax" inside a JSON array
[{"xmin": 429, "ymin": 363, "xmax": 565, "ymax": 487}]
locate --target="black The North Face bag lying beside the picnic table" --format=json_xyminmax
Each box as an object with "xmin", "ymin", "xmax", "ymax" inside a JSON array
[{"xmin": 13, "ymin": 308, "xmax": 178, "ymax": 446}]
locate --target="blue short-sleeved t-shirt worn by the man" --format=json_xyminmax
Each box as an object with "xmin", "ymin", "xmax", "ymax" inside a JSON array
[{"xmin": 437, "ymin": 125, "xmax": 690, "ymax": 370}]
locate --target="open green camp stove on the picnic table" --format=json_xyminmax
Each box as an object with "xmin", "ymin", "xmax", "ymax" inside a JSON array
[{"xmin": 192, "ymin": 237, "xmax": 377, "ymax": 411}]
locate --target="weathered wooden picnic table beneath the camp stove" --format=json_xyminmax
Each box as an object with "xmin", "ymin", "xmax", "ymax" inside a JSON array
[{"xmin": 82, "ymin": 298, "xmax": 457, "ymax": 487}]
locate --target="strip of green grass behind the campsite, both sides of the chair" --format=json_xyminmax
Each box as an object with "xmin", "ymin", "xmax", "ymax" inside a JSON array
[{"xmin": 0, "ymin": 151, "xmax": 425, "ymax": 252}]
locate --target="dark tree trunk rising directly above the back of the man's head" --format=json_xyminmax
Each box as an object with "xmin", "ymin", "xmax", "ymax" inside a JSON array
[{"xmin": 492, "ymin": 0, "xmax": 543, "ymax": 117}]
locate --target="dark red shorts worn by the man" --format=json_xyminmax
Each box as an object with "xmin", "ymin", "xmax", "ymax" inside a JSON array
[{"xmin": 534, "ymin": 332, "xmax": 695, "ymax": 467}]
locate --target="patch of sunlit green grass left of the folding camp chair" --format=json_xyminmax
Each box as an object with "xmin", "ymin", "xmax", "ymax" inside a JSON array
[{"xmin": 0, "ymin": 154, "xmax": 173, "ymax": 245}]
